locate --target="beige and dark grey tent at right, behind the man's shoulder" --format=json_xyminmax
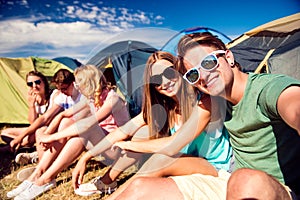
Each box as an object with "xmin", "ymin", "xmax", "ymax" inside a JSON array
[{"xmin": 228, "ymin": 13, "xmax": 300, "ymax": 79}]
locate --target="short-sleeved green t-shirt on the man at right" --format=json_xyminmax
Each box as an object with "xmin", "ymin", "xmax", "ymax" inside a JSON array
[{"xmin": 225, "ymin": 73, "xmax": 300, "ymax": 194}]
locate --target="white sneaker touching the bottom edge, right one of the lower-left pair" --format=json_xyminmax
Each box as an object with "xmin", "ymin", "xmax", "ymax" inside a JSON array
[{"xmin": 14, "ymin": 179, "xmax": 56, "ymax": 200}]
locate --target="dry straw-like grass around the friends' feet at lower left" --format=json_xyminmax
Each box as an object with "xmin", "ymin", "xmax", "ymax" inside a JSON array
[{"xmin": 0, "ymin": 124, "xmax": 136, "ymax": 200}]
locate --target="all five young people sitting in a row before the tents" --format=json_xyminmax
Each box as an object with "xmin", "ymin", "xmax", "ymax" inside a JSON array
[{"xmin": 2, "ymin": 33, "xmax": 300, "ymax": 199}]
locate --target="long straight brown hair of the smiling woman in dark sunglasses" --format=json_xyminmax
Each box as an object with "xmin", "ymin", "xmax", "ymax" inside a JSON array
[{"xmin": 142, "ymin": 51, "xmax": 196, "ymax": 138}]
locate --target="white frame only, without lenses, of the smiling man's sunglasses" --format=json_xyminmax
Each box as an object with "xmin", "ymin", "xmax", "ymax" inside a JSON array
[{"xmin": 183, "ymin": 50, "xmax": 226, "ymax": 85}]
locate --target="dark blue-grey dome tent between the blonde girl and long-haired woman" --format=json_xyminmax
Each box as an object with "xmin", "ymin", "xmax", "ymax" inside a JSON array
[{"xmin": 87, "ymin": 40, "xmax": 157, "ymax": 116}]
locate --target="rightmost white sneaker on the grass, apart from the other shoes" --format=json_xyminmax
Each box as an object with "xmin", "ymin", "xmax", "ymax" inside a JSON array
[{"xmin": 75, "ymin": 176, "xmax": 118, "ymax": 196}]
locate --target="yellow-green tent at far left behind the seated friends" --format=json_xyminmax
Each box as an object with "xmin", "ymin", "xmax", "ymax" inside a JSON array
[{"xmin": 0, "ymin": 57, "xmax": 72, "ymax": 124}]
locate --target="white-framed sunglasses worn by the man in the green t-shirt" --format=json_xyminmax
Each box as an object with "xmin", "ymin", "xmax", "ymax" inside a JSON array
[{"xmin": 183, "ymin": 50, "xmax": 226, "ymax": 84}]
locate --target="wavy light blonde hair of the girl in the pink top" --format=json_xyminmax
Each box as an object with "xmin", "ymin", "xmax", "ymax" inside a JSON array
[{"xmin": 74, "ymin": 65, "xmax": 110, "ymax": 107}]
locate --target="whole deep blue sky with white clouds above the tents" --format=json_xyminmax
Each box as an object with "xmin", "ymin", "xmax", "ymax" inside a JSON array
[{"xmin": 0, "ymin": 0, "xmax": 300, "ymax": 62}]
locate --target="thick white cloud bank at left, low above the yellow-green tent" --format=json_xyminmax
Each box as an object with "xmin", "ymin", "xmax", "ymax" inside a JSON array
[{"xmin": 0, "ymin": 20, "xmax": 111, "ymax": 59}]
